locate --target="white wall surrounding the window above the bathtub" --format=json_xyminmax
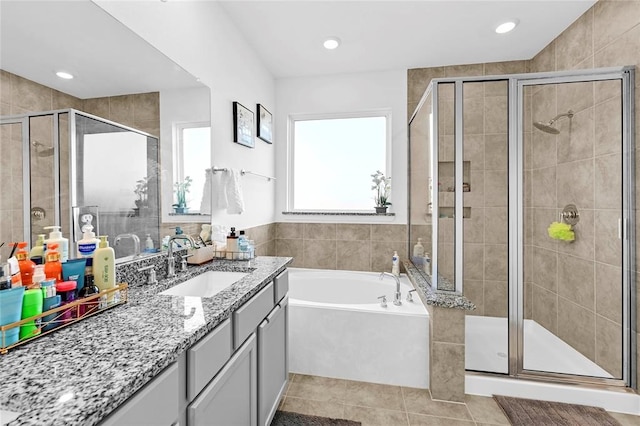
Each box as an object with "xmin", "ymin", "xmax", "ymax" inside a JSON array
[{"xmin": 275, "ymin": 70, "xmax": 407, "ymax": 224}]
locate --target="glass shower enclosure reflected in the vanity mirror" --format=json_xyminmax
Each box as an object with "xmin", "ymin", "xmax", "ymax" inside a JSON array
[{"xmin": 0, "ymin": 109, "xmax": 160, "ymax": 258}]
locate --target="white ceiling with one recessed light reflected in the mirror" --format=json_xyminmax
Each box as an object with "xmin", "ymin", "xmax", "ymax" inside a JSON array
[{"xmin": 0, "ymin": 0, "xmax": 202, "ymax": 99}]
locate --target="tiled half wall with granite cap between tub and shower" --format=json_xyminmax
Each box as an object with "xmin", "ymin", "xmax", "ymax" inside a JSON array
[{"xmin": 404, "ymin": 262, "xmax": 475, "ymax": 402}]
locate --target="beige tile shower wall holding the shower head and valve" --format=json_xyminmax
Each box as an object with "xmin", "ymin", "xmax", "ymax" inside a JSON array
[{"xmin": 530, "ymin": 0, "xmax": 640, "ymax": 377}]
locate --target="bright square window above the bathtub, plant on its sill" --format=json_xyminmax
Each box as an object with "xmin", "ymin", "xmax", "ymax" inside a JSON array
[{"xmin": 288, "ymin": 111, "xmax": 391, "ymax": 212}]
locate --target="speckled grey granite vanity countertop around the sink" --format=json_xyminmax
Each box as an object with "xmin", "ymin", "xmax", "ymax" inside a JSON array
[{"xmin": 0, "ymin": 257, "xmax": 292, "ymax": 426}]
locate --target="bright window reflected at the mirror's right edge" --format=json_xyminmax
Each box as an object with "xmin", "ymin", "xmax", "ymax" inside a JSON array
[{"xmin": 171, "ymin": 123, "xmax": 211, "ymax": 213}]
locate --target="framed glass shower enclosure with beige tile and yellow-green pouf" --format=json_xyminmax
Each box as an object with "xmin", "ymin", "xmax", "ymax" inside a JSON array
[{"xmin": 409, "ymin": 67, "xmax": 637, "ymax": 387}]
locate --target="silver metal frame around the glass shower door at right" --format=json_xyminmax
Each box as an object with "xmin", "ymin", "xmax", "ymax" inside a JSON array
[{"xmin": 508, "ymin": 67, "xmax": 637, "ymax": 388}]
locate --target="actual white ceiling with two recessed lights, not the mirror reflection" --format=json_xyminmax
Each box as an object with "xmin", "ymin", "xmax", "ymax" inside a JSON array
[{"xmin": 221, "ymin": 0, "xmax": 595, "ymax": 77}]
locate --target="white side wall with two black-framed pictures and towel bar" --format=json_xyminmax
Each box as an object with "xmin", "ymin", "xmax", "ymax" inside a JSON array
[{"xmin": 93, "ymin": 0, "xmax": 276, "ymax": 228}]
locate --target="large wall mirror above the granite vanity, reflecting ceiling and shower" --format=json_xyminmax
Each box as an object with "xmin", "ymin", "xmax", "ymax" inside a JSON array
[{"xmin": 0, "ymin": 1, "xmax": 210, "ymax": 258}]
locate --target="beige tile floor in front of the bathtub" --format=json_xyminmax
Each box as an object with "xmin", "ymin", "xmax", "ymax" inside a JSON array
[{"xmin": 280, "ymin": 374, "xmax": 640, "ymax": 426}]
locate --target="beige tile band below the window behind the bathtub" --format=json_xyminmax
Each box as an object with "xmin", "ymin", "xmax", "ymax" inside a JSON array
[{"xmin": 276, "ymin": 222, "xmax": 407, "ymax": 272}]
